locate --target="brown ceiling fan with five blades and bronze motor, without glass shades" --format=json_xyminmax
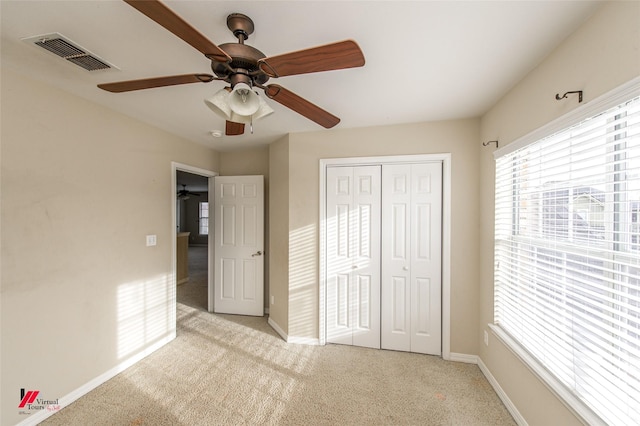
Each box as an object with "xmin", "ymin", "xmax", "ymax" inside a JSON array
[{"xmin": 98, "ymin": 0, "xmax": 365, "ymax": 136}]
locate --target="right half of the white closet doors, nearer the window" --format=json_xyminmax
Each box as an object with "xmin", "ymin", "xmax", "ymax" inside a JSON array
[{"xmin": 381, "ymin": 163, "xmax": 442, "ymax": 355}]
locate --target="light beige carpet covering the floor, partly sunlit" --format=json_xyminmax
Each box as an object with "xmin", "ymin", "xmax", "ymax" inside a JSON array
[{"xmin": 44, "ymin": 245, "xmax": 515, "ymax": 426}]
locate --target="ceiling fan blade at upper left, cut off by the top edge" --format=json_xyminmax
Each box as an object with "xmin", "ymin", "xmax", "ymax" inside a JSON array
[{"xmin": 124, "ymin": 0, "xmax": 231, "ymax": 62}]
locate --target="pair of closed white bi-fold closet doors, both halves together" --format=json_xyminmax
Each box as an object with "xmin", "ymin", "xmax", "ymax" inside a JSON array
[{"xmin": 326, "ymin": 162, "xmax": 442, "ymax": 355}]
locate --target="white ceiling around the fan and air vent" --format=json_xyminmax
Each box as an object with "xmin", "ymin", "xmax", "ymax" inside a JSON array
[{"xmin": 0, "ymin": 0, "xmax": 601, "ymax": 151}]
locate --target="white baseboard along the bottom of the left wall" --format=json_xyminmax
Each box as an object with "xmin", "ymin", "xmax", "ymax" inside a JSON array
[{"xmin": 18, "ymin": 331, "xmax": 176, "ymax": 426}]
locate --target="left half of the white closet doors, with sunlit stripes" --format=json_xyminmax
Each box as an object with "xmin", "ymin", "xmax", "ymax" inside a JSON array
[{"xmin": 326, "ymin": 166, "xmax": 380, "ymax": 348}]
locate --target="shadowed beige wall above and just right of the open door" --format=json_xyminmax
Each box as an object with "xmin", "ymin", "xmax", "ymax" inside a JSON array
[{"xmin": 218, "ymin": 146, "xmax": 271, "ymax": 308}]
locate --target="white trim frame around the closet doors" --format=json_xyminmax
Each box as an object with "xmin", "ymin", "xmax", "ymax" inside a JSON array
[{"xmin": 318, "ymin": 153, "xmax": 451, "ymax": 360}]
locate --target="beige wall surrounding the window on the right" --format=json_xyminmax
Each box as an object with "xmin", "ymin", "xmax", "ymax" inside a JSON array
[{"xmin": 476, "ymin": 2, "xmax": 640, "ymax": 425}]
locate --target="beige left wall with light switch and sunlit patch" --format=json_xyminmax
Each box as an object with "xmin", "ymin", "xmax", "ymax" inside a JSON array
[{"xmin": 0, "ymin": 69, "xmax": 218, "ymax": 425}]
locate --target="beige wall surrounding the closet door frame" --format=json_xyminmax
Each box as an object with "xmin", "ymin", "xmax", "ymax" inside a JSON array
[{"xmin": 271, "ymin": 119, "xmax": 479, "ymax": 354}]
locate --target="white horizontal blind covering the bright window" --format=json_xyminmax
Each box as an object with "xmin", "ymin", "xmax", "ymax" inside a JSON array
[{"xmin": 494, "ymin": 97, "xmax": 640, "ymax": 425}]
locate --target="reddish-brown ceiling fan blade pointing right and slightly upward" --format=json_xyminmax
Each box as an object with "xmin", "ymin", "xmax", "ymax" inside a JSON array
[{"xmin": 258, "ymin": 40, "xmax": 364, "ymax": 77}]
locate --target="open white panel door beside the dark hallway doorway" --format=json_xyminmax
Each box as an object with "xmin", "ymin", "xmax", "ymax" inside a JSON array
[{"xmin": 213, "ymin": 176, "xmax": 264, "ymax": 316}]
